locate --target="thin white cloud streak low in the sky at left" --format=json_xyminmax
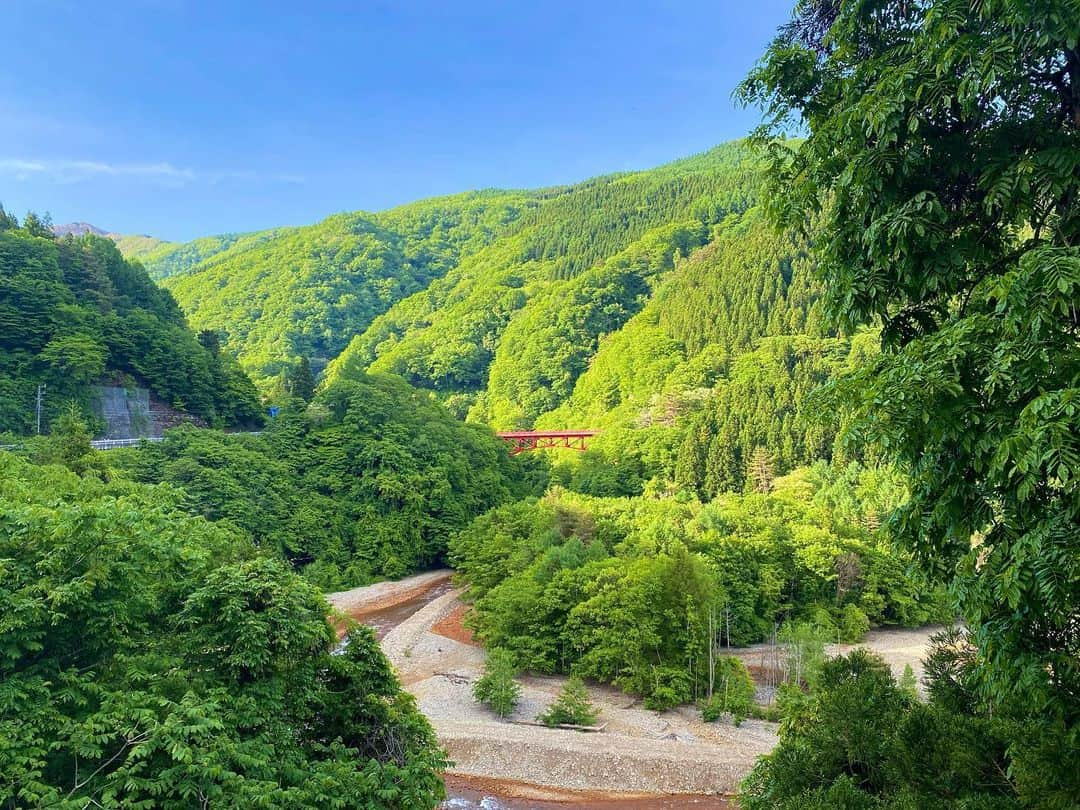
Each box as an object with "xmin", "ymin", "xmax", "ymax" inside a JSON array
[{"xmin": 0, "ymin": 158, "xmax": 303, "ymax": 186}]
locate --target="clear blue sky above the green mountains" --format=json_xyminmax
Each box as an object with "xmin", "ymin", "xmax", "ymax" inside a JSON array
[{"xmin": 0, "ymin": 0, "xmax": 794, "ymax": 240}]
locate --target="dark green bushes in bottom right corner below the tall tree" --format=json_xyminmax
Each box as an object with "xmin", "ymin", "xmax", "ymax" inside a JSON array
[{"xmin": 740, "ymin": 631, "xmax": 1076, "ymax": 810}]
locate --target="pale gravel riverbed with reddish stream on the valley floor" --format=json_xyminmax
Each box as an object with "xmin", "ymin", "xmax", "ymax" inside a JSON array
[{"xmin": 327, "ymin": 571, "xmax": 937, "ymax": 810}]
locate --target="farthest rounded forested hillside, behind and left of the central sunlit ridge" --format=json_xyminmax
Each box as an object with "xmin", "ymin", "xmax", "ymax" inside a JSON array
[{"xmin": 157, "ymin": 192, "xmax": 530, "ymax": 390}]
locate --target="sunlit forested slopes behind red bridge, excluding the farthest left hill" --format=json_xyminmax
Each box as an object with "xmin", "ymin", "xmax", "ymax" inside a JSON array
[{"xmin": 326, "ymin": 144, "xmax": 842, "ymax": 498}]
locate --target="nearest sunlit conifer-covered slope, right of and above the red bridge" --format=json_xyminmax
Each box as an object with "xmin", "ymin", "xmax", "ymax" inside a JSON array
[{"xmin": 520, "ymin": 207, "xmax": 842, "ymax": 496}]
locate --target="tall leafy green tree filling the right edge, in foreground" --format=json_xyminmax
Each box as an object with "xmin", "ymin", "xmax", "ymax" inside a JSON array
[{"xmin": 743, "ymin": 0, "xmax": 1080, "ymax": 800}]
